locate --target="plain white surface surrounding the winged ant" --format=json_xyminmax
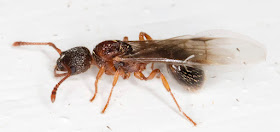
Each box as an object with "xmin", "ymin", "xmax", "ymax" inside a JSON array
[{"xmin": 0, "ymin": 0, "xmax": 280, "ymax": 132}]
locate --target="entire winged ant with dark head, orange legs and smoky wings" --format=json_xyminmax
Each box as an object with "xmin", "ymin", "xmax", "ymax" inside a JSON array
[{"xmin": 13, "ymin": 29, "xmax": 266, "ymax": 125}]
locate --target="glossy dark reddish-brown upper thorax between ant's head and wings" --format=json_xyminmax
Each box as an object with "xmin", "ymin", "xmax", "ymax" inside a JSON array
[{"xmin": 92, "ymin": 40, "xmax": 132, "ymax": 67}]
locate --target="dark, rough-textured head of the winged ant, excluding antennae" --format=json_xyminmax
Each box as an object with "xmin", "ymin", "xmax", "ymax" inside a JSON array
[{"xmin": 55, "ymin": 47, "xmax": 92, "ymax": 75}]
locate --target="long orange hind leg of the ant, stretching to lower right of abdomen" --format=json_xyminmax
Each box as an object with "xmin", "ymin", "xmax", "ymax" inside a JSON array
[{"xmin": 134, "ymin": 69, "xmax": 196, "ymax": 126}]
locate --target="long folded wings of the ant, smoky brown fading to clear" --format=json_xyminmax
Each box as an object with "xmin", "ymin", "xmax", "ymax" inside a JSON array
[{"xmin": 118, "ymin": 30, "xmax": 266, "ymax": 65}]
